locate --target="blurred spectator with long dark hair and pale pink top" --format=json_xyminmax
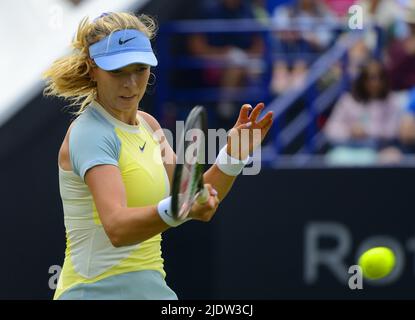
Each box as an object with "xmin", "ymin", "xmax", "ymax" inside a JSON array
[{"xmin": 324, "ymin": 60, "xmax": 403, "ymax": 155}]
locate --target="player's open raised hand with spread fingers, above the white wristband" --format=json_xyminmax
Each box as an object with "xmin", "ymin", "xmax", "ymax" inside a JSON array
[{"xmin": 226, "ymin": 102, "xmax": 274, "ymax": 159}]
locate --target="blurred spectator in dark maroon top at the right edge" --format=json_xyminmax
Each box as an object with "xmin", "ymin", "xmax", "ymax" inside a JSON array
[{"xmin": 387, "ymin": 5, "xmax": 415, "ymax": 90}]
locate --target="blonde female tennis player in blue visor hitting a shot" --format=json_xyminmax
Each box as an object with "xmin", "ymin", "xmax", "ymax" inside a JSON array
[{"xmin": 44, "ymin": 13, "xmax": 272, "ymax": 300}]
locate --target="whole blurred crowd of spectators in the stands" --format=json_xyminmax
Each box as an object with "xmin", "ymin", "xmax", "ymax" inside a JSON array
[{"xmin": 162, "ymin": 0, "xmax": 415, "ymax": 161}]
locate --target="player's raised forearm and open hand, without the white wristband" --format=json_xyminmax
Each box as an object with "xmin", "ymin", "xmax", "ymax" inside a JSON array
[{"xmin": 203, "ymin": 103, "xmax": 273, "ymax": 201}]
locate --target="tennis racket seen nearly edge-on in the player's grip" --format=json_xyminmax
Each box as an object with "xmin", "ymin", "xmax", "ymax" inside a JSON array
[{"xmin": 171, "ymin": 106, "xmax": 209, "ymax": 220}]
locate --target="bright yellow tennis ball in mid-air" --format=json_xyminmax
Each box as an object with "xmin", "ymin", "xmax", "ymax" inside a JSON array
[{"xmin": 358, "ymin": 247, "xmax": 395, "ymax": 280}]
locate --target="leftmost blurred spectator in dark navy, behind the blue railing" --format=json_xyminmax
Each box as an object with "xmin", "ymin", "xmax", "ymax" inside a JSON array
[{"xmin": 189, "ymin": 0, "xmax": 264, "ymax": 127}]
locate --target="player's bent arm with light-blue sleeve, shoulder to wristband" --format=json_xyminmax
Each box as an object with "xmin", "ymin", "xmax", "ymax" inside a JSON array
[{"xmin": 69, "ymin": 114, "xmax": 219, "ymax": 247}]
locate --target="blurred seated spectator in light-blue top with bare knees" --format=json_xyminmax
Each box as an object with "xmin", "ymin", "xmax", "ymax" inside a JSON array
[{"xmin": 271, "ymin": 0, "xmax": 334, "ymax": 94}]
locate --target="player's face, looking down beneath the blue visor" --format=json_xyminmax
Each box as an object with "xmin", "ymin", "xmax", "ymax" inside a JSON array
[{"xmin": 93, "ymin": 64, "xmax": 150, "ymax": 110}]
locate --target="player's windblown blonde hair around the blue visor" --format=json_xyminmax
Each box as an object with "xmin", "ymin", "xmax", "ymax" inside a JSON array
[{"xmin": 43, "ymin": 12, "xmax": 157, "ymax": 115}]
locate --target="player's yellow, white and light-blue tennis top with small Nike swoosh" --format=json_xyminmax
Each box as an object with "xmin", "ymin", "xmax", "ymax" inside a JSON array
[{"xmin": 54, "ymin": 101, "xmax": 170, "ymax": 299}]
